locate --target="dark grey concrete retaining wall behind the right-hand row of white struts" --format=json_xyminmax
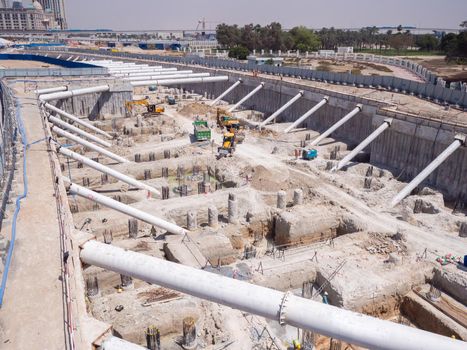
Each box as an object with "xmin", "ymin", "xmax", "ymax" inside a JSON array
[{"xmin": 183, "ymin": 75, "xmax": 467, "ymax": 201}]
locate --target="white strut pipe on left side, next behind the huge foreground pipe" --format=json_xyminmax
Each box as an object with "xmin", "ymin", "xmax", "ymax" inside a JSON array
[{"xmin": 69, "ymin": 183, "xmax": 188, "ymax": 236}]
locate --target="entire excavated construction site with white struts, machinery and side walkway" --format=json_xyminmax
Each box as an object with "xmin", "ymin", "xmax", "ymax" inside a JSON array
[{"xmin": 0, "ymin": 49, "xmax": 467, "ymax": 350}]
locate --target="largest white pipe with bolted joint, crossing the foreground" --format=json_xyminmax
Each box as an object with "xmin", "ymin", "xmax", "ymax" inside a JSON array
[{"xmin": 80, "ymin": 241, "xmax": 465, "ymax": 350}]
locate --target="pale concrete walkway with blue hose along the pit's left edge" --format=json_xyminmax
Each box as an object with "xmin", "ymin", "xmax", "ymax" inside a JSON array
[{"xmin": 0, "ymin": 89, "xmax": 66, "ymax": 350}]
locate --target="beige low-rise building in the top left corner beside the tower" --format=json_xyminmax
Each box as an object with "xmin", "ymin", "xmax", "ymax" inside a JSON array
[{"xmin": 0, "ymin": 1, "xmax": 57, "ymax": 31}]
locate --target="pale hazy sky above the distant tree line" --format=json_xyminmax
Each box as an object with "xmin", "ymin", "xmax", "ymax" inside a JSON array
[{"xmin": 58, "ymin": 0, "xmax": 467, "ymax": 30}]
